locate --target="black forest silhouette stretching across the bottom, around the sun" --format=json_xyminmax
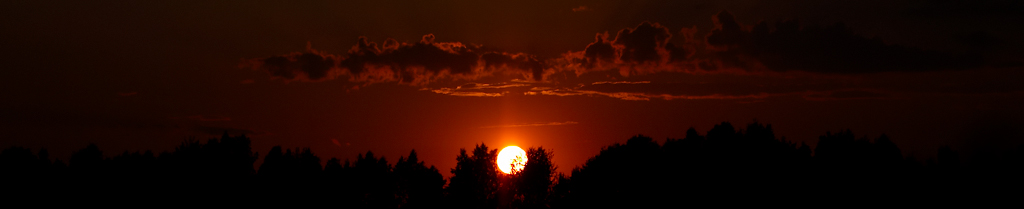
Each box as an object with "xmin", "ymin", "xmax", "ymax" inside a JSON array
[{"xmin": 0, "ymin": 122, "xmax": 1024, "ymax": 208}]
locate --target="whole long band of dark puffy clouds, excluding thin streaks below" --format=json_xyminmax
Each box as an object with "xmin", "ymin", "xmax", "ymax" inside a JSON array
[{"xmin": 252, "ymin": 11, "xmax": 997, "ymax": 86}]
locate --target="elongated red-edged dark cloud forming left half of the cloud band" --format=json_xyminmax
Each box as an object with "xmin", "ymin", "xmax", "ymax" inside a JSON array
[{"xmin": 250, "ymin": 34, "xmax": 544, "ymax": 85}]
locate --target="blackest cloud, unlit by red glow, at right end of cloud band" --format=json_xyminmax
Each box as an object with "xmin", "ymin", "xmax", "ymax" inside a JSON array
[{"xmin": 707, "ymin": 11, "xmax": 980, "ymax": 74}]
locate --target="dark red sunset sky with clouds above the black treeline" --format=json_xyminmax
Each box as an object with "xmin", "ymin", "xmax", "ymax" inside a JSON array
[{"xmin": 0, "ymin": 0, "xmax": 1024, "ymax": 175}]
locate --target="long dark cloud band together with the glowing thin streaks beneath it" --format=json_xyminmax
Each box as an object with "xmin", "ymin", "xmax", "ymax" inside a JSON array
[{"xmin": 245, "ymin": 11, "xmax": 1015, "ymax": 100}]
